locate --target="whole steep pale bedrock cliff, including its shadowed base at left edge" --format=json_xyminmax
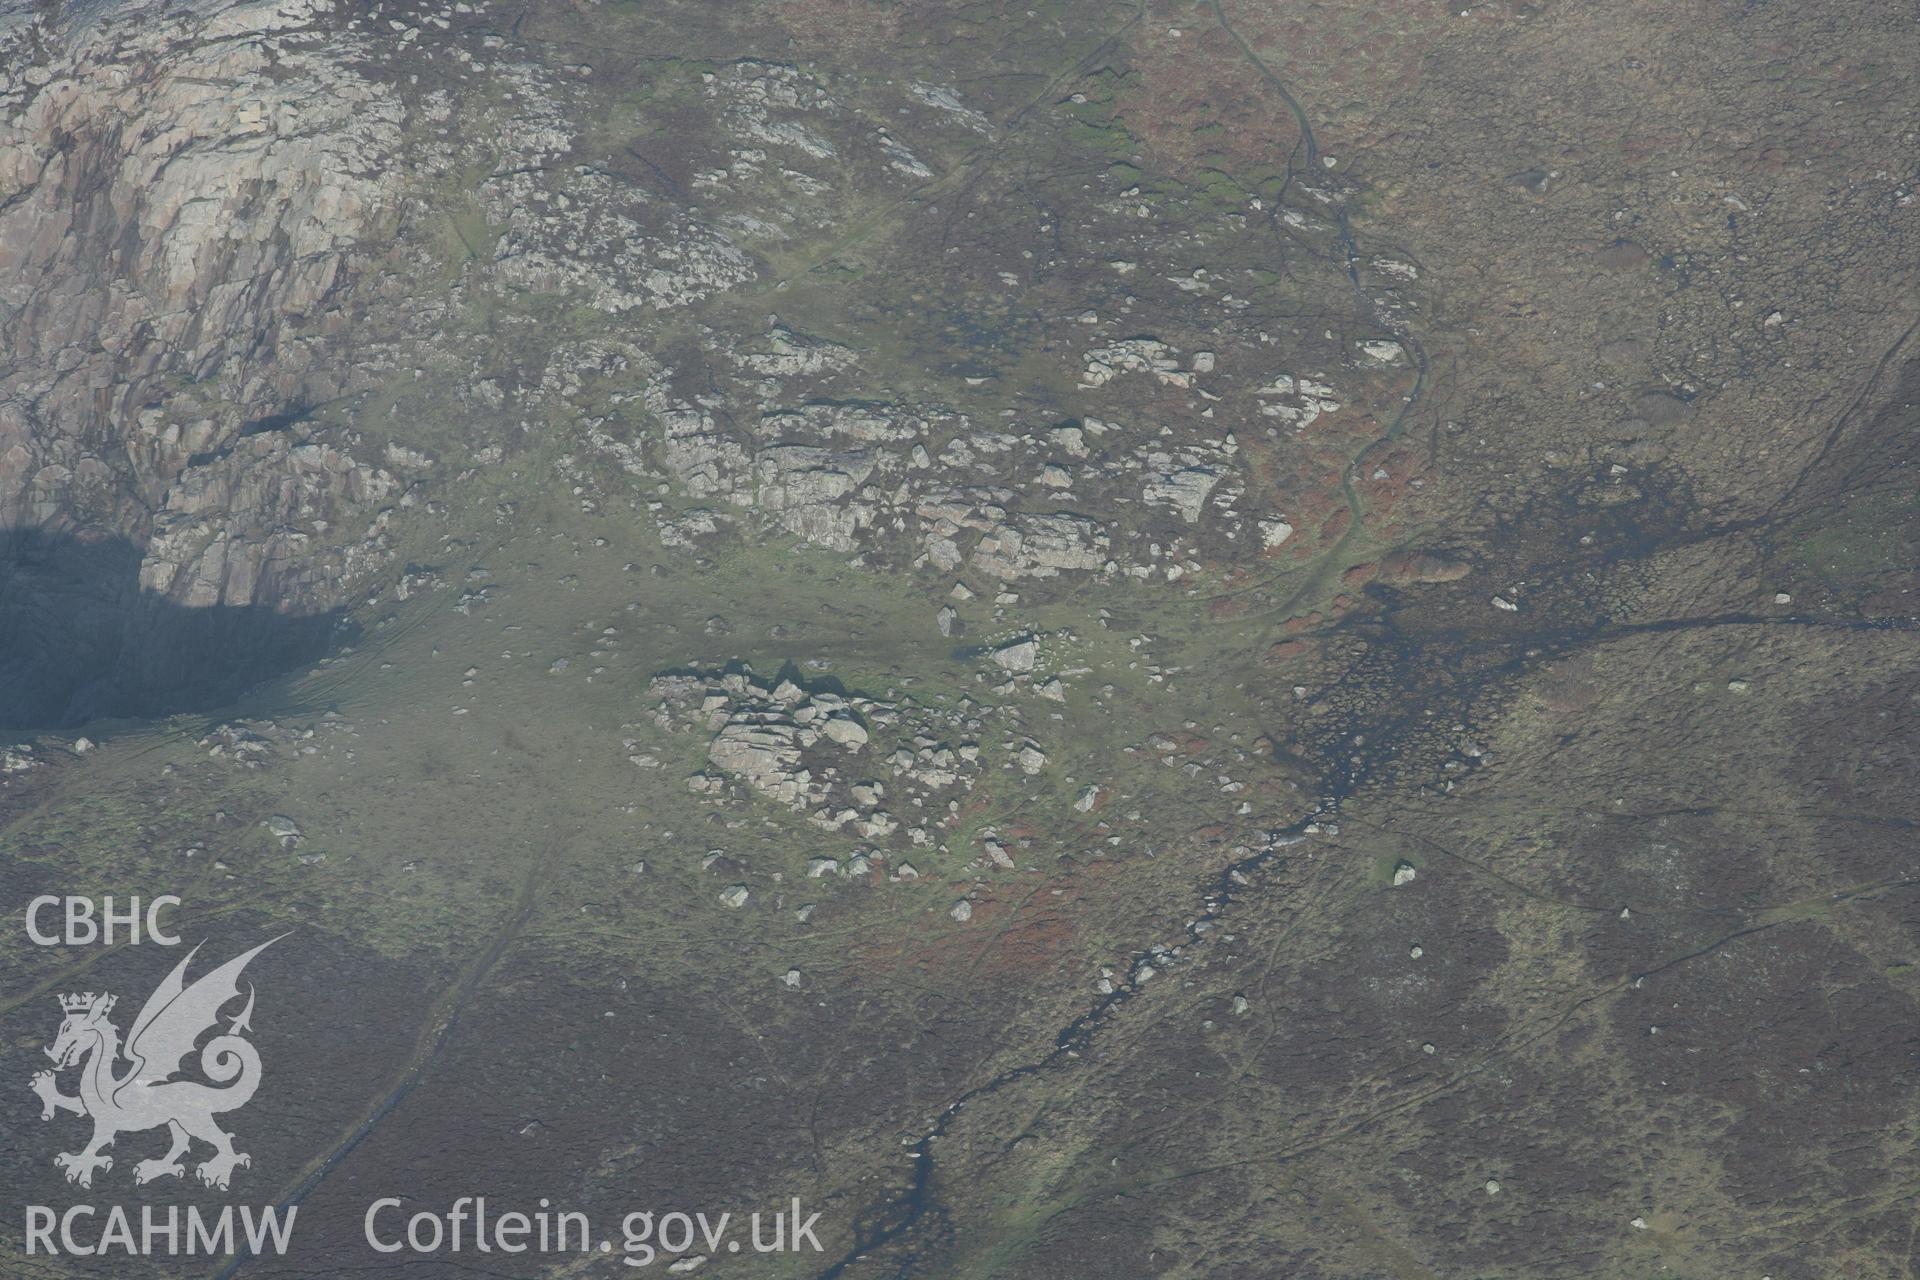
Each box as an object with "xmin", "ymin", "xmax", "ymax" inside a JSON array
[{"xmin": 0, "ymin": 0, "xmax": 403, "ymax": 718}]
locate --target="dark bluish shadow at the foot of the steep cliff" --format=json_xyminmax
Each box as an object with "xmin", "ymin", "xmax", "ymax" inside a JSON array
[{"xmin": 0, "ymin": 530, "xmax": 342, "ymax": 729}]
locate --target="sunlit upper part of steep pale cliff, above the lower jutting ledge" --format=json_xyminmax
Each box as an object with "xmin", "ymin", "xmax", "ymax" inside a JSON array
[{"xmin": 0, "ymin": 2, "xmax": 401, "ymax": 521}]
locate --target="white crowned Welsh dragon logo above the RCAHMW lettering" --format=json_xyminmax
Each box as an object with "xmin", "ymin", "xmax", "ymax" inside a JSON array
[{"xmin": 33, "ymin": 935, "xmax": 286, "ymax": 1190}]
